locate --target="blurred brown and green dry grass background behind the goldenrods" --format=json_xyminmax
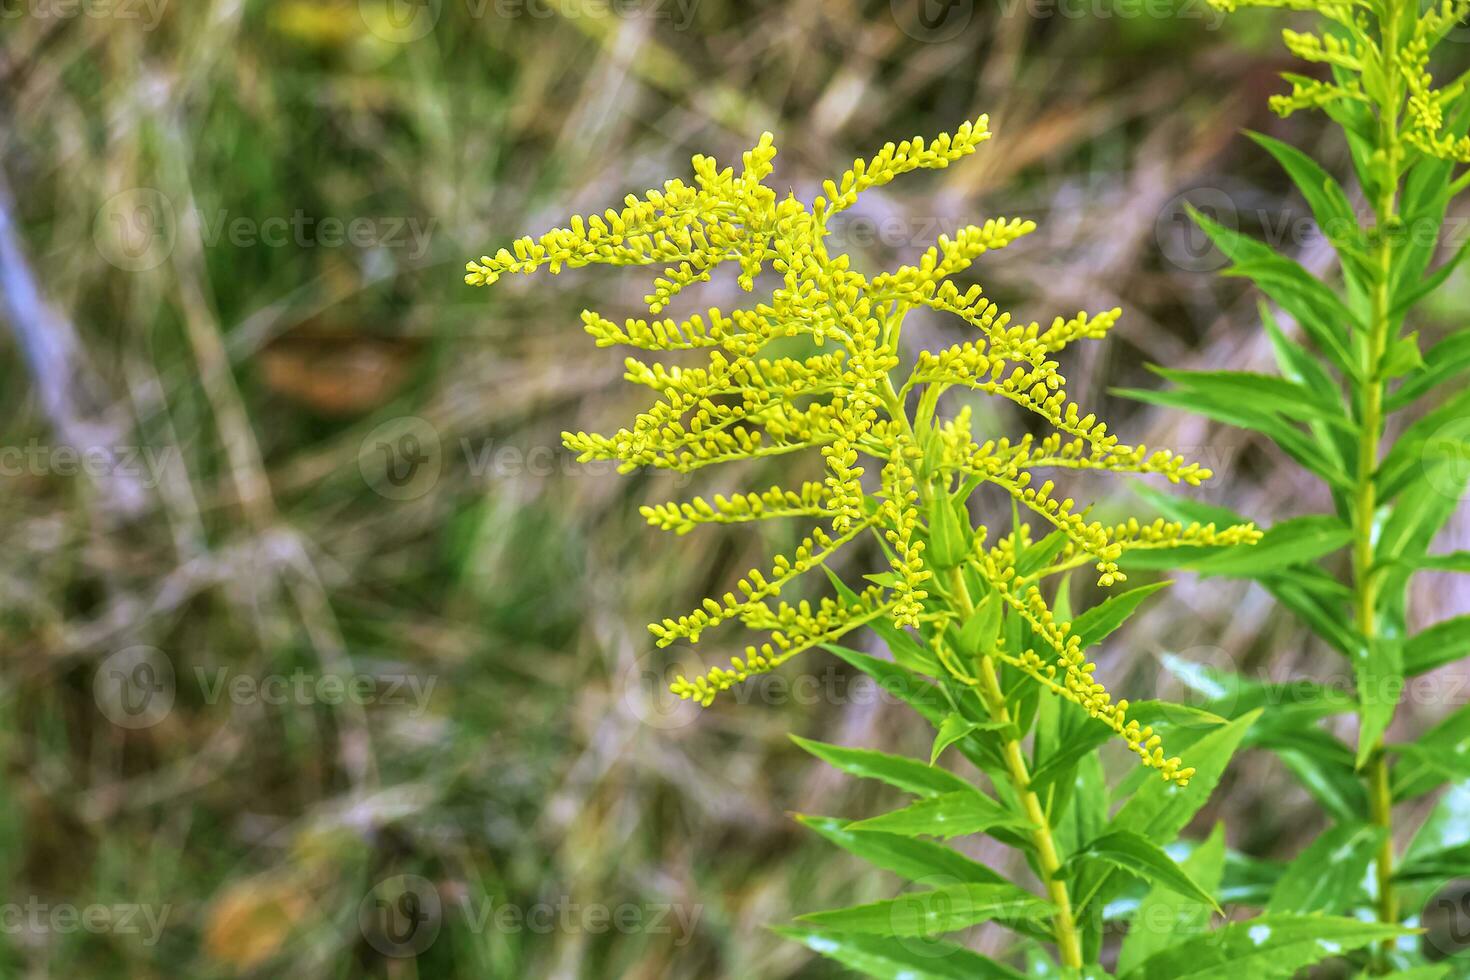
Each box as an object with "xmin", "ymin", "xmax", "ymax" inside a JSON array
[{"xmin": 0, "ymin": 0, "xmax": 1470, "ymax": 980}]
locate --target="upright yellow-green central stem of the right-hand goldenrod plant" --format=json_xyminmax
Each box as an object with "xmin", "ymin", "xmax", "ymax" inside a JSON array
[{"xmin": 1352, "ymin": 3, "xmax": 1402, "ymax": 949}]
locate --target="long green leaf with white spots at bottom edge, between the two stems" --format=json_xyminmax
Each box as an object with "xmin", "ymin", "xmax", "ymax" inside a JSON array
[{"xmin": 1123, "ymin": 915, "xmax": 1410, "ymax": 980}]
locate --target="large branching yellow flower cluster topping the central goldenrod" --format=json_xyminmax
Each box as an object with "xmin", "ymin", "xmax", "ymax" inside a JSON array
[{"xmin": 465, "ymin": 116, "xmax": 1257, "ymax": 783}]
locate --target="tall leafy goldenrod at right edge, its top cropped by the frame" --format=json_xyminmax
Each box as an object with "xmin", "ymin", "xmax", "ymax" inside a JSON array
[{"xmin": 1132, "ymin": 0, "xmax": 1470, "ymax": 977}]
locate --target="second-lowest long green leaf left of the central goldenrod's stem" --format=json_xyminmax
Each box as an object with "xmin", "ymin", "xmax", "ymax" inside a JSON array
[{"xmin": 797, "ymin": 884, "xmax": 1057, "ymax": 937}]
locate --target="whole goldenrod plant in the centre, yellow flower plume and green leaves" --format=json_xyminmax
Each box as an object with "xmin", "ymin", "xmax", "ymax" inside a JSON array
[{"xmin": 466, "ymin": 116, "xmax": 1394, "ymax": 979}]
